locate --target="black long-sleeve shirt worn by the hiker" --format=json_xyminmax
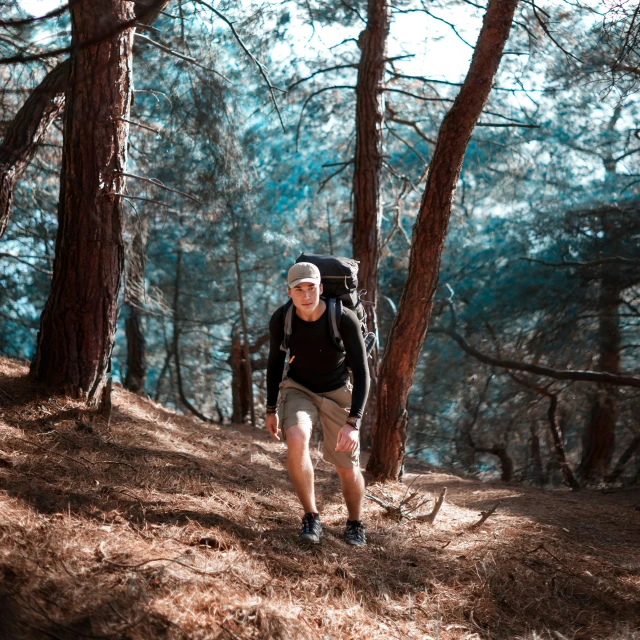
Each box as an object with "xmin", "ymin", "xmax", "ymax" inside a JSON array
[{"xmin": 267, "ymin": 304, "xmax": 369, "ymax": 418}]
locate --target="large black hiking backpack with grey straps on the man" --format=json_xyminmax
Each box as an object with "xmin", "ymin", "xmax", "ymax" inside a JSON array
[{"xmin": 280, "ymin": 253, "xmax": 376, "ymax": 356}]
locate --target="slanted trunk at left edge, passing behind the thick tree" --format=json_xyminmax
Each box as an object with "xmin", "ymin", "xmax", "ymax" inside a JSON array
[{"xmin": 0, "ymin": 0, "xmax": 170, "ymax": 238}]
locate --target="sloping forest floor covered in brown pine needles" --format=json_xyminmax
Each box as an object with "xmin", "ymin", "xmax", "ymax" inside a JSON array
[{"xmin": 0, "ymin": 359, "xmax": 640, "ymax": 640}]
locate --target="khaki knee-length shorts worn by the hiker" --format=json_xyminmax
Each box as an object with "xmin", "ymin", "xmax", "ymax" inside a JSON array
[{"xmin": 278, "ymin": 378, "xmax": 360, "ymax": 469}]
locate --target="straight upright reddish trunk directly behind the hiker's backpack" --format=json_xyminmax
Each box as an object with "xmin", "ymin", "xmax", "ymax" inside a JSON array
[{"xmin": 353, "ymin": 0, "xmax": 389, "ymax": 447}]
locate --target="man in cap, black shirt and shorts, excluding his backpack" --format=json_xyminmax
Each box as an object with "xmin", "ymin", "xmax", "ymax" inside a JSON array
[{"xmin": 266, "ymin": 262, "xmax": 369, "ymax": 546}]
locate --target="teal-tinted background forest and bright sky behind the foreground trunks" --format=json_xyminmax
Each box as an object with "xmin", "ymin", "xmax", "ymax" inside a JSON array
[{"xmin": 0, "ymin": 0, "xmax": 640, "ymax": 486}]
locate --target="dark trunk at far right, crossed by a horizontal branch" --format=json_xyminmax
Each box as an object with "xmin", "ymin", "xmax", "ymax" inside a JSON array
[{"xmin": 578, "ymin": 266, "xmax": 620, "ymax": 481}]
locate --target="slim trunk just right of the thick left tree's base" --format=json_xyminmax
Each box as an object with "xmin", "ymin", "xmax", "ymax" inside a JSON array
[{"xmin": 124, "ymin": 216, "xmax": 148, "ymax": 393}]
